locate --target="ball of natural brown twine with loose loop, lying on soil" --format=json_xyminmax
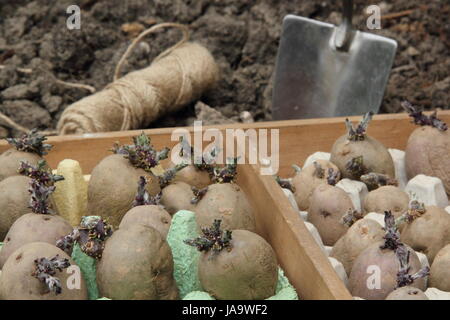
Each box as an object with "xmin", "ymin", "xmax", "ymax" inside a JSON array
[{"xmin": 57, "ymin": 23, "xmax": 218, "ymax": 135}]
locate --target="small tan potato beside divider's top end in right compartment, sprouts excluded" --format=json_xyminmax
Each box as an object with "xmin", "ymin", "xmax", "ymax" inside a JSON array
[{"xmin": 292, "ymin": 160, "xmax": 340, "ymax": 210}]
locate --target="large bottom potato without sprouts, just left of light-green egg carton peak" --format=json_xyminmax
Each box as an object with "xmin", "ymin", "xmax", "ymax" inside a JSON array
[{"xmin": 97, "ymin": 224, "xmax": 178, "ymax": 300}]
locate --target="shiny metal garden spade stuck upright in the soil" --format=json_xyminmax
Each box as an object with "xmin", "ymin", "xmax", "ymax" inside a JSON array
[{"xmin": 272, "ymin": 0, "xmax": 397, "ymax": 120}]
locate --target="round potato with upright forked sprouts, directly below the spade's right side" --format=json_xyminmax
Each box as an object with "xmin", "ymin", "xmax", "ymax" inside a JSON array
[{"xmin": 330, "ymin": 113, "xmax": 395, "ymax": 180}]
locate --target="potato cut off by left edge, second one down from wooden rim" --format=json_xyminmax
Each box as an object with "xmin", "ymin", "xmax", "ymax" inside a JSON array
[{"xmin": 0, "ymin": 176, "xmax": 31, "ymax": 241}]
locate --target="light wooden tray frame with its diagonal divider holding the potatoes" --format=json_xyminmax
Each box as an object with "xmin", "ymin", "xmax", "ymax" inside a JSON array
[{"xmin": 0, "ymin": 111, "xmax": 450, "ymax": 299}]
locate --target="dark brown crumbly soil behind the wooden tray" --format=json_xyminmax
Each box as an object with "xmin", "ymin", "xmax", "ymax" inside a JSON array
[{"xmin": 0, "ymin": 0, "xmax": 450, "ymax": 136}]
